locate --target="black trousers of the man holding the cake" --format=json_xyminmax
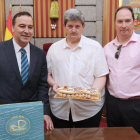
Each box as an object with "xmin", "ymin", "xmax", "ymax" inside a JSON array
[{"xmin": 51, "ymin": 109, "xmax": 102, "ymax": 128}]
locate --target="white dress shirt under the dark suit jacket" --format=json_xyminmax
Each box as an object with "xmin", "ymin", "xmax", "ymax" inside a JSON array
[{"xmin": 13, "ymin": 38, "xmax": 30, "ymax": 74}]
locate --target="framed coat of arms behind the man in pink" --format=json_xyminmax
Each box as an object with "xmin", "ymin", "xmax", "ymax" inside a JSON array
[{"xmin": 119, "ymin": 0, "xmax": 140, "ymax": 34}]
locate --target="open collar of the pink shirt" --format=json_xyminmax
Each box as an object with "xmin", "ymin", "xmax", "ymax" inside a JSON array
[{"xmin": 112, "ymin": 32, "xmax": 138, "ymax": 46}]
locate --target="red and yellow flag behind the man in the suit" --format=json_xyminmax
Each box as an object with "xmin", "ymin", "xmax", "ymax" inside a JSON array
[{"xmin": 4, "ymin": 4, "xmax": 14, "ymax": 41}]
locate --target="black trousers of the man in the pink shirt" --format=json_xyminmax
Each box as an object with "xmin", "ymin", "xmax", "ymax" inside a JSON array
[{"xmin": 106, "ymin": 91, "xmax": 140, "ymax": 134}]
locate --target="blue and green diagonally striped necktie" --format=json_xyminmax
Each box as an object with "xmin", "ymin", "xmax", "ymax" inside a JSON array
[{"xmin": 20, "ymin": 48, "xmax": 29, "ymax": 85}]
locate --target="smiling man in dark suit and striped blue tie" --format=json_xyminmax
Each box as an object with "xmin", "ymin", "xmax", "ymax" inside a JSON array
[{"xmin": 0, "ymin": 12, "xmax": 53, "ymax": 130}]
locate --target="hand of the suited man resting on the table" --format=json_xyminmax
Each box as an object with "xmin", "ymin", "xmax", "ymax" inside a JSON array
[{"xmin": 44, "ymin": 115, "xmax": 54, "ymax": 130}]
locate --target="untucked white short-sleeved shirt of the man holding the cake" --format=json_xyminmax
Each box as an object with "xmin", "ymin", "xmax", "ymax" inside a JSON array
[{"xmin": 47, "ymin": 36, "xmax": 108, "ymax": 121}]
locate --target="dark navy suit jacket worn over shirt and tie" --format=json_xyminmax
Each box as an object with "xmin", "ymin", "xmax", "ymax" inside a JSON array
[{"xmin": 0, "ymin": 39, "xmax": 50, "ymax": 115}]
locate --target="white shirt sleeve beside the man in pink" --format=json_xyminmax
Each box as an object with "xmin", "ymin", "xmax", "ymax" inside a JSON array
[{"xmin": 94, "ymin": 47, "xmax": 109, "ymax": 77}]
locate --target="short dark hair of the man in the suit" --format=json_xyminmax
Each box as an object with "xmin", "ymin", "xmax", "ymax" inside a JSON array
[{"xmin": 12, "ymin": 11, "xmax": 33, "ymax": 26}]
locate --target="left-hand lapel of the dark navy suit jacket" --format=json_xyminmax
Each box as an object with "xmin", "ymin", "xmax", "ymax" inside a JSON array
[{"xmin": 3, "ymin": 39, "xmax": 22, "ymax": 84}]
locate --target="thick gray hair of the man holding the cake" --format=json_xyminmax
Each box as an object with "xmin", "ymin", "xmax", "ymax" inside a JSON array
[{"xmin": 64, "ymin": 9, "xmax": 85, "ymax": 25}]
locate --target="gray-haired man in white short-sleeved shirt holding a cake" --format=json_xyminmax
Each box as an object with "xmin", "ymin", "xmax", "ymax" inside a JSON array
[{"xmin": 47, "ymin": 9, "xmax": 108, "ymax": 128}]
